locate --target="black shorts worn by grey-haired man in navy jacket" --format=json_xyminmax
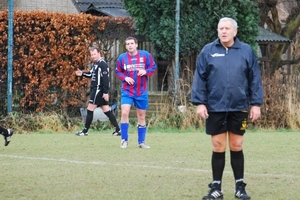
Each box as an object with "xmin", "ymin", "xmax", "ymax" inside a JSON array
[{"xmin": 206, "ymin": 111, "xmax": 248, "ymax": 135}]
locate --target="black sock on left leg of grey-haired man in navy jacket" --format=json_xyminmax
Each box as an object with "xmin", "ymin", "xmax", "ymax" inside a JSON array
[{"xmin": 211, "ymin": 152, "xmax": 225, "ymax": 189}]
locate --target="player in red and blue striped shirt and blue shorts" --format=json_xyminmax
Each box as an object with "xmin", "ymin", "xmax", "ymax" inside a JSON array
[{"xmin": 116, "ymin": 37, "xmax": 156, "ymax": 148}]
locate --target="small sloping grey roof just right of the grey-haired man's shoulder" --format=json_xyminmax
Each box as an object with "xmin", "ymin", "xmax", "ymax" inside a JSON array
[{"xmin": 256, "ymin": 27, "xmax": 292, "ymax": 43}]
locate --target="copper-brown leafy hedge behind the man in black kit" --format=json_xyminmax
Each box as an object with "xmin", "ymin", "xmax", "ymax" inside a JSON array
[{"xmin": 0, "ymin": 10, "xmax": 132, "ymax": 111}]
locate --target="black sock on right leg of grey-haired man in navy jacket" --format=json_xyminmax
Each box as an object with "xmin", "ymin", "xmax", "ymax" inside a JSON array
[{"xmin": 230, "ymin": 150, "xmax": 244, "ymax": 180}]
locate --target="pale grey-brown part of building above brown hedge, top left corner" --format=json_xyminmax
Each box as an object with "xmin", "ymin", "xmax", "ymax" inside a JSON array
[{"xmin": 0, "ymin": 0, "xmax": 78, "ymax": 14}]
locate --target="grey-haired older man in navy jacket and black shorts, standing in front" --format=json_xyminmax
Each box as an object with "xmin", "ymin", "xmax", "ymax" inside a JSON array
[{"xmin": 191, "ymin": 17, "xmax": 263, "ymax": 200}]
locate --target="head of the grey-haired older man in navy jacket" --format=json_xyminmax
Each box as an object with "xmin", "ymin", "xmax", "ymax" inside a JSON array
[{"xmin": 218, "ymin": 21, "xmax": 237, "ymax": 47}]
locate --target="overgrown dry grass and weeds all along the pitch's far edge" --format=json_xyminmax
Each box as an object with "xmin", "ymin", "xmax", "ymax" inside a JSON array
[{"xmin": 1, "ymin": 64, "xmax": 300, "ymax": 133}]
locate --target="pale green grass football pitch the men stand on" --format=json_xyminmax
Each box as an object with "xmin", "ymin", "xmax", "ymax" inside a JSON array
[{"xmin": 0, "ymin": 130, "xmax": 300, "ymax": 200}]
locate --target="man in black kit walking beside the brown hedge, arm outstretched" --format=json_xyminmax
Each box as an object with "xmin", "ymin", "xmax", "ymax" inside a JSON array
[{"xmin": 75, "ymin": 44, "xmax": 121, "ymax": 136}]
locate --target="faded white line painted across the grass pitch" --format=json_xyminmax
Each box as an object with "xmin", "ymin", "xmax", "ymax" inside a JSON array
[{"xmin": 0, "ymin": 154, "xmax": 300, "ymax": 179}]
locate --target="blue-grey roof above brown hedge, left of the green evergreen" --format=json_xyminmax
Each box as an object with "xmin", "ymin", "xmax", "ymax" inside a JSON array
[{"xmin": 73, "ymin": 0, "xmax": 129, "ymax": 17}]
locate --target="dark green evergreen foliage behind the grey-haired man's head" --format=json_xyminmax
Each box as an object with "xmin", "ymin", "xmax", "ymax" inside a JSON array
[{"xmin": 123, "ymin": 0, "xmax": 258, "ymax": 59}]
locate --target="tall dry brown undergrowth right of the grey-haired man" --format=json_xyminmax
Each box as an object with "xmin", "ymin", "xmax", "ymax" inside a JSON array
[{"xmin": 256, "ymin": 75, "xmax": 300, "ymax": 130}]
